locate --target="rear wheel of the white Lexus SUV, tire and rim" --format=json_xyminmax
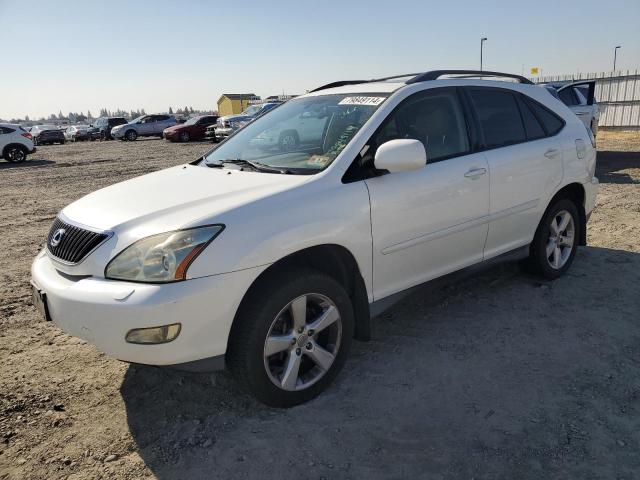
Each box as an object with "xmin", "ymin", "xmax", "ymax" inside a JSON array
[{"xmin": 525, "ymin": 198, "xmax": 581, "ymax": 279}]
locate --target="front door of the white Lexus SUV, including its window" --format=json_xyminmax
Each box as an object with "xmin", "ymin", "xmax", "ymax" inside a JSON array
[{"xmin": 365, "ymin": 88, "xmax": 489, "ymax": 299}]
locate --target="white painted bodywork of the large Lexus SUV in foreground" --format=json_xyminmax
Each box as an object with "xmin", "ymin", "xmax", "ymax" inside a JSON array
[{"xmin": 31, "ymin": 79, "xmax": 597, "ymax": 365}]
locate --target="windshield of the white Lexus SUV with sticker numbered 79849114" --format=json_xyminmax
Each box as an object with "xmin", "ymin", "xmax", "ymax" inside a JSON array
[{"xmin": 204, "ymin": 94, "xmax": 388, "ymax": 173}]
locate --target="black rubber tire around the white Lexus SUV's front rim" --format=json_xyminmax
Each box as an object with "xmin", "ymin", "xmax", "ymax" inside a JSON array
[{"xmin": 227, "ymin": 268, "xmax": 355, "ymax": 407}]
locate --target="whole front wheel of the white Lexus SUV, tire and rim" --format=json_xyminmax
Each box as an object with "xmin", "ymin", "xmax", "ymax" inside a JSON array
[{"xmin": 228, "ymin": 269, "xmax": 354, "ymax": 407}]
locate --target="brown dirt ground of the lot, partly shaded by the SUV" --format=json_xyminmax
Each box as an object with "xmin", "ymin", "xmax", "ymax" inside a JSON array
[{"xmin": 0, "ymin": 132, "xmax": 640, "ymax": 479}]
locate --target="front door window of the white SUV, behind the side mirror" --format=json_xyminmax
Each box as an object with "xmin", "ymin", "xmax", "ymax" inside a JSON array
[{"xmin": 373, "ymin": 90, "xmax": 470, "ymax": 163}]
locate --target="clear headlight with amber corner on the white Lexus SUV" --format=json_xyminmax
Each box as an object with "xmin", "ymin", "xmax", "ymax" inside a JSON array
[{"xmin": 104, "ymin": 225, "xmax": 224, "ymax": 283}]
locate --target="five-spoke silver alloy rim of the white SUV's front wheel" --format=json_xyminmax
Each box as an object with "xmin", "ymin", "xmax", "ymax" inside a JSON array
[{"xmin": 263, "ymin": 293, "xmax": 342, "ymax": 391}]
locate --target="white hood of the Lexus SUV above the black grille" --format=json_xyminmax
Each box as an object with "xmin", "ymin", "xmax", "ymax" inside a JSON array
[{"xmin": 62, "ymin": 165, "xmax": 310, "ymax": 234}]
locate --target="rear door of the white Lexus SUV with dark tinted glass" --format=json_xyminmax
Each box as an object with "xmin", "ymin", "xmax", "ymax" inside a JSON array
[{"xmin": 465, "ymin": 87, "xmax": 564, "ymax": 259}]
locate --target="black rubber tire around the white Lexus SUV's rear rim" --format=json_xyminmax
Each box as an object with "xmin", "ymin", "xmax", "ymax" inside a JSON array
[{"xmin": 523, "ymin": 198, "xmax": 582, "ymax": 280}]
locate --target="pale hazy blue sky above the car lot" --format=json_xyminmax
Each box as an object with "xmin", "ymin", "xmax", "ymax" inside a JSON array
[{"xmin": 0, "ymin": 0, "xmax": 640, "ymax": 119}]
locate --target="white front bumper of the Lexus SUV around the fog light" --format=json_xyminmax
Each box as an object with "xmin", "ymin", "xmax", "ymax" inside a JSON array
[{"xmin": 31, "ymin": 252, "xmax": 266, "ymax": 366}]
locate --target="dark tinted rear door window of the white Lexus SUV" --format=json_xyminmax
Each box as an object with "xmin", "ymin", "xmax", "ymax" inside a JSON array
[{"xmin": 469, "ymin": 88, "xmax": 527, "ymax": 148}]
